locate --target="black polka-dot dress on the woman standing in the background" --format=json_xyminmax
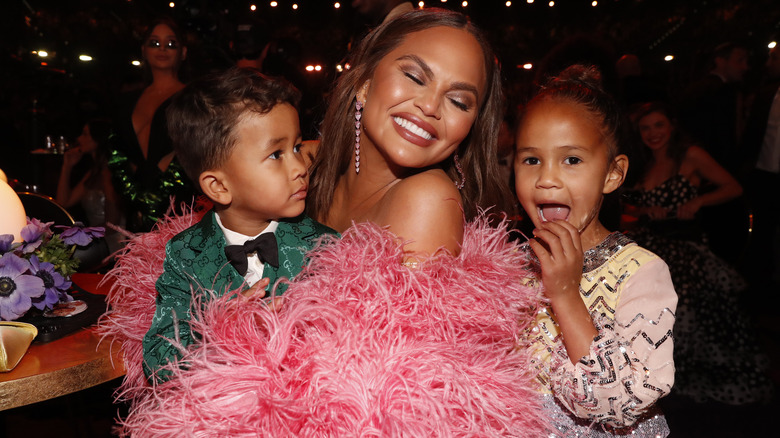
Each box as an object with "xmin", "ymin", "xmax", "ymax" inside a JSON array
[{"xmin": 626, "ymin": 175, "xmax": 774, "ymax": 405}]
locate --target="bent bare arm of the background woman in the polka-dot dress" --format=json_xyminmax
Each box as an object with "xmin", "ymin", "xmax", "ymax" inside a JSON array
[{"xmin": 677, "ymin": 146, "xmax": 742, "ymax": 219}]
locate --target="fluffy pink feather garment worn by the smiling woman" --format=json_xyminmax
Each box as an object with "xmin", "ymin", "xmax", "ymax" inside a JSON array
[{"xmin": 102, "ymin": 213, "xmax": 546, "ymax": 437}]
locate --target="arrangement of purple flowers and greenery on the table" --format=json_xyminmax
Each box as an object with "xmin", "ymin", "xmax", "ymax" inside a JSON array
[{"xmin": 0, "ymin": 218, "xmax": 105, "ymax": 321}]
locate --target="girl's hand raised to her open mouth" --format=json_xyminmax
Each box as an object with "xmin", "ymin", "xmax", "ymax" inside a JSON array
[{"xmin": 529, "ymin": 221, "xmax": 584, "ymax": 305}]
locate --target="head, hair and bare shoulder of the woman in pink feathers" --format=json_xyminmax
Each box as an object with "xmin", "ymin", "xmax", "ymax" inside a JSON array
[{"xmin": 309, "ymin": 9, "xmax": 511, "ymax": 260}]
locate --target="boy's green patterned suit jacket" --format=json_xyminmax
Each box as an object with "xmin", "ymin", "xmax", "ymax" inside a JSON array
[{"xmin": 143, "ymin": 211, "xmax": 337, "ymax": 380}]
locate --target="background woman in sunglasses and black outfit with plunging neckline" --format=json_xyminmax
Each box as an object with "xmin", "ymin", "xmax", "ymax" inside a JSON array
[{"xmin": 109, "ymin": 18, "xmax": 194, "ymax": 231}]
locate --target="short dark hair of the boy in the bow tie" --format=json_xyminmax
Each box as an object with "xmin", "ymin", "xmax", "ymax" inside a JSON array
[{"xmin": 165, "ymin": 67, "xmax": 301, "ymax": 185}]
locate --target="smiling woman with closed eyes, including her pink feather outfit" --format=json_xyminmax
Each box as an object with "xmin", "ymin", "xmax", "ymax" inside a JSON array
[{"xmin": 97, "ymin": 10, "xmax": 547, "ymax": 437}]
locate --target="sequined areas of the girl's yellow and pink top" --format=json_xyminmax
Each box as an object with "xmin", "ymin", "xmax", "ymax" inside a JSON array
[{"xmin": 527, "ymin": 233, "xmax": 676, "ymax": 436}]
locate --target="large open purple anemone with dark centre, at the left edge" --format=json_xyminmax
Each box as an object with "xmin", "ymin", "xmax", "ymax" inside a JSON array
[{"xmin": 0, "ymin": 253, "xmax": 44, "ymax": 321}]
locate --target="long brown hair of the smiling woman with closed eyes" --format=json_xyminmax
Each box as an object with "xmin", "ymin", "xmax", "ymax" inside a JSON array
[{"xmin": 307, "ymin": 8, "xmax": 513, "ymax": 220}]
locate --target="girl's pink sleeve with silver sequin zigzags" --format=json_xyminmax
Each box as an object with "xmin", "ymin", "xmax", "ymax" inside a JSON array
[{"xmin": 550, "ymin": 259, "xmax": 677, "ymax": 427}]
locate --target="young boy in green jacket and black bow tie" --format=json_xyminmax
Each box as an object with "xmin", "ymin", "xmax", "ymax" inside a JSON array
[{"xmin": 143, "ymin": 68, "xmax": 335, "ymax": 381}]
